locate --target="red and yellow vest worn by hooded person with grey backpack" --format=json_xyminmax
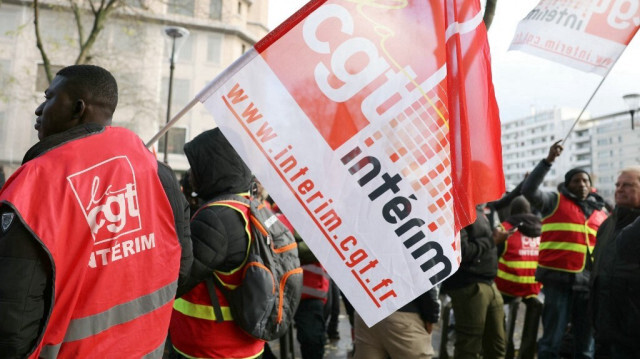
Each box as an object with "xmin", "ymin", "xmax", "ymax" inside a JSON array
[{"xmin": 169, "ymin": 200, "xmax": 264, "ymax": 359}]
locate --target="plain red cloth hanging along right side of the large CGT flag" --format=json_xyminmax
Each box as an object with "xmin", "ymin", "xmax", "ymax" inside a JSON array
[{"xmin": 446, "ymin": 0, "xmax": 505, "ymax": 229}]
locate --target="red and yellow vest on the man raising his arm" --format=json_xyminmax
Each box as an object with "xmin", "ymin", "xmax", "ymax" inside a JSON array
[{"xmin": 538, "ymin": 193, "xmax": 607, "ymax": 273}]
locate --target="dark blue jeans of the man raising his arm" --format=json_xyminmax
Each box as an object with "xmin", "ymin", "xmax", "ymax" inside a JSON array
[{"xmin": 538, "ymin": 285, "xmax": 594, "ymax": 359}]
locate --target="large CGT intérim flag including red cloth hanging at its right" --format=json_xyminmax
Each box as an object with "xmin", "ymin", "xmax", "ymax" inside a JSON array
[{"xmin": 198, "ymin": 0, "xmax": 504, "ymax": 325}]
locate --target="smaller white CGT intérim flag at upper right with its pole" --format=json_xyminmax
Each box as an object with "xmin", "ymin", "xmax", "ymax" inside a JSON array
[{"xmin": 509, "ymin": 0, "xmax": 640, "ymax": 143}]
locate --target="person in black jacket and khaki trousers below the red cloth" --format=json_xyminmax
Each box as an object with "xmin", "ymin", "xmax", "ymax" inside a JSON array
[{"xmin": 442, "ymin": 205, "xmax": 508, "ymax": 358}]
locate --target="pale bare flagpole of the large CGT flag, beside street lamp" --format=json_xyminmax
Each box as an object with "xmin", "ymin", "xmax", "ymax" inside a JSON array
[{"xmin": 146, "ymin": 48, "xmax": 258, "ymax": 147}]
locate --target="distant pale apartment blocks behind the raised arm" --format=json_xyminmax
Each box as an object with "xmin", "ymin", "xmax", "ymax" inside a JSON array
[{"xmin": 502, "ymin": 108, "xmax": 640, "ymax": 207}]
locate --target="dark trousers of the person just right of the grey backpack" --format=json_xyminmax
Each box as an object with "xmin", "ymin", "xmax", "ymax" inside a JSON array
[{"xmin": 293, "ymin": 299, "xmax": 327, "ymax": 359}]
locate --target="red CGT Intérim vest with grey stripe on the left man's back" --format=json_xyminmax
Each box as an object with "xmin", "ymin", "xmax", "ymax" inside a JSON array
[{"xmin": 0, "ymin": 127, "xmax": 181, "ymax": 358}]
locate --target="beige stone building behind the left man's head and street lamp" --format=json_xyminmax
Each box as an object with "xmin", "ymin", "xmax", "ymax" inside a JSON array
[{"xmin": 0, "ymin": 0, "xmax": 269, "ymax": 174}]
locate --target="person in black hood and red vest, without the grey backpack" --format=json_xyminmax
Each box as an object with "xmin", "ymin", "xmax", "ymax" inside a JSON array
[{"xmin": 169, "ymin": 128, "xmax": 264, "ymax": 358}]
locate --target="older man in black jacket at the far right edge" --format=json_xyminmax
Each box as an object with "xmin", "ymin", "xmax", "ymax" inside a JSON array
[{"xmin": 590, "ymin": 166, "xmax": 640, "ymax": 358}]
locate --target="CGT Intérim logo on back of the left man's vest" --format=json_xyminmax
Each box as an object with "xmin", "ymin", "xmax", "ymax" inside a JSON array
[{"xmin": 67, "ymin": 156, "xmax": 155, "ymax": 268}]
